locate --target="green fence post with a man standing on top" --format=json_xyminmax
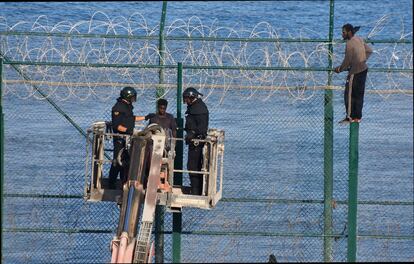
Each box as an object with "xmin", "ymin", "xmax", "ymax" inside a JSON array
[{"xmin": 348, "ymin": 122, "xmax": 359, "ymax": 262}]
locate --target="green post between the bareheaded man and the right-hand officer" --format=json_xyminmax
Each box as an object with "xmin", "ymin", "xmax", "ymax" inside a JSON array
[{"xmin": 173, "ymin": 62, "xmax": 184, "ymax": 263}]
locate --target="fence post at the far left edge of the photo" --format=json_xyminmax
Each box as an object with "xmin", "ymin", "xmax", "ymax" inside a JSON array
[{"xmin": 0, "ymin": 56, "xmax": 4, "ymax": 260}]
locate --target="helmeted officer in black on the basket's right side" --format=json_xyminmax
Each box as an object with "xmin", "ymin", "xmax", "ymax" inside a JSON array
[{"xmin": 183, "ymin": 87, "xmax": 209, "ymax": 195}]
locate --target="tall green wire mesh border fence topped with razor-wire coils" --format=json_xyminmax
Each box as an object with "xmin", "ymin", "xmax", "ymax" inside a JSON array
[{"xmin": 0, "ymin": 0, "xmax": 414, "ymax": 263}]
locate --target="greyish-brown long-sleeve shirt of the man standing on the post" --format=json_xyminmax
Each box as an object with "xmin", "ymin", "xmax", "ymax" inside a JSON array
[{"xmin": 339, "ymin": 36, "xmax": 372, "ymax": 74}]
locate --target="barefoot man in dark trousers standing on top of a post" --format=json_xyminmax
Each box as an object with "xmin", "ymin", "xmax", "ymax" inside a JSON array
[{"xmin": 335, "ymin": 24, "xmax": 372, "ymax": 124}]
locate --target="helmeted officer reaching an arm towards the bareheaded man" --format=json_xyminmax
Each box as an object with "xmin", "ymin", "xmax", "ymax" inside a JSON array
[{"xmin": 109, "ymin": 86, "xmax": 149, "ymax": 189}]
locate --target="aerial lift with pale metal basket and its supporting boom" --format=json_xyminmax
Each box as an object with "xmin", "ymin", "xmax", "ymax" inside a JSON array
[{"xmin": 84, "ymin": 121, "xmax": 224, "ymax": 263}]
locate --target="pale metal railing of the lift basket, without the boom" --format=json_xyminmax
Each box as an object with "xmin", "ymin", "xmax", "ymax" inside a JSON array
[{"xmin": 84, "ymin": 121, "xmax": 224, "ymax": 212}]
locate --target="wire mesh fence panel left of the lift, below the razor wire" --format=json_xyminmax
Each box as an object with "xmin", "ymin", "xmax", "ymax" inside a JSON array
[{"xmin": 2, "ymin": 62, "xmax": 175, "ymax": 262}]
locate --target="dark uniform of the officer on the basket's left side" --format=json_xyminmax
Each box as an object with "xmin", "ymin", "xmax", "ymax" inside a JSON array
[{"xmin": 109, "ymin": 98, "xmax": 135, "ymax": 189}]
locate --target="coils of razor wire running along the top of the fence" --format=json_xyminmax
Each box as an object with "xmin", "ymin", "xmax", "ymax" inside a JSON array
[{"xmin": 0, "ymin": 11, "xmax": 413, "ymax": 101}]
